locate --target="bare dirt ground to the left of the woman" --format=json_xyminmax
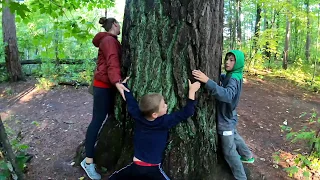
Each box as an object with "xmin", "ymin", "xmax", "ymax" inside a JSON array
[{"xmin": 0, "ymin": 81, "xmax": 92, "ymax": 180}]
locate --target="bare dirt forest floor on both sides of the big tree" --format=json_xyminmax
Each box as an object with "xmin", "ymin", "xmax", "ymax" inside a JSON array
[{"xmin": 0, "ymin": 77, "xmax": 320, "ymax": 180}]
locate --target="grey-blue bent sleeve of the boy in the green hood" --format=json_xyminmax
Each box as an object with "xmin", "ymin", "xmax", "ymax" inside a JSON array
[{"xmin": 206, "ymin": 78, "xmax": 238, "ymax": 103}]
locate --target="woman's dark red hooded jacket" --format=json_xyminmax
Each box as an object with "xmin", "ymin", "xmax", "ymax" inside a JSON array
[{"xmin": 92, "ymin": 32, "xmax": 121, "ymax": 88}]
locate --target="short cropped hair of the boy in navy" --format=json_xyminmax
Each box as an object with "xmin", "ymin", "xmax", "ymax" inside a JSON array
[{"xmin": 139, "ymin": 93, "xmax": 163, "ymax": 117}]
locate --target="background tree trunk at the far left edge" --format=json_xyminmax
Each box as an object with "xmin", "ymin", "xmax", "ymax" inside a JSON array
[{"xmin": 2, "ymin": 1, "xmax": 24, "ymax": 81}]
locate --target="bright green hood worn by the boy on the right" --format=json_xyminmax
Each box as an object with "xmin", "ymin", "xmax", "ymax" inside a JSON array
[{"xmin": 225, "ymin": 50, "xmax": 244, "ymax": 80}]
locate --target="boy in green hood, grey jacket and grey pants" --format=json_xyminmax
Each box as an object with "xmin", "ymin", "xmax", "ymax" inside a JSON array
[{"xmin": 192, "ymin": 50, "xmax": 254, "ymax": 180}]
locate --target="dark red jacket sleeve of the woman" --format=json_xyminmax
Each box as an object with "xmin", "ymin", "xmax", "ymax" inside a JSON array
[{"xmin": 100, "ymin": 37, "xmax": 121, "ymax": 84}]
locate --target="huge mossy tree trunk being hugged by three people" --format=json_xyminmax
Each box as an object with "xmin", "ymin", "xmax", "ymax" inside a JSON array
[{"xmin": 90, "ymin": 0, "xmax": 242, "ymax": 180}]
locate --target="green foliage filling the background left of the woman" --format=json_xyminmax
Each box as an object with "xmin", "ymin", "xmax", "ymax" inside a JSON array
[{"xmin": 0, "ymin": 0, "xmax": 119, "ymax": 84}]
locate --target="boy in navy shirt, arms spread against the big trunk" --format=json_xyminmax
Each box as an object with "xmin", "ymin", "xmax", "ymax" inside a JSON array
[{"xmin": 109, "ymin": 79, "xmax": 200, "ymax": 180}]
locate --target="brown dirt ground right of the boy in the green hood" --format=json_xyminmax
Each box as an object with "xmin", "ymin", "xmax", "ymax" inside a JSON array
[{"xmin": 238, "ymin": 78, "xmax": 320, "ymax": 180}]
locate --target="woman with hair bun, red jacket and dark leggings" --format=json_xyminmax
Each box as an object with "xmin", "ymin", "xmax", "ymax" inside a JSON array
[{"xmin": 81, "ymin": 17, "xmax": 129, "ymax": 179}]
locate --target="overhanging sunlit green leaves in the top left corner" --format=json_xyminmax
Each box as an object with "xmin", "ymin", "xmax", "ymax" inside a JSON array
[{"xmin": 1, "ymin": 0, "xmax": 114, "ymax": 41}]
